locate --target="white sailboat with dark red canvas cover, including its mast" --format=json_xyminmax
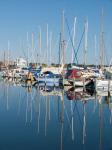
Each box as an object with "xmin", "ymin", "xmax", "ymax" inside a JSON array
[{"xmin": 61, "ymin": 19, "xmax": 94, "ymax": 87}]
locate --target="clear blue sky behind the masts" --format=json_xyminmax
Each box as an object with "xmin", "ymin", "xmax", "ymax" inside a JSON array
[{"xmin": 0, "ymin": 0, "xmax": 112, "ymax": 64}]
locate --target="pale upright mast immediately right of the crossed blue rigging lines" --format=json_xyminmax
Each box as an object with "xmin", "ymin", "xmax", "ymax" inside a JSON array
[{"xmin": 84, "ymin": 20, "xmax": 88, "ymax": 66}]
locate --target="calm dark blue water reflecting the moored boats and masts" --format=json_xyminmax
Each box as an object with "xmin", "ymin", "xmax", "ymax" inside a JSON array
[{"xmin": 0, "ymin": 81, "xmax": 112, "ymax": 150}]
